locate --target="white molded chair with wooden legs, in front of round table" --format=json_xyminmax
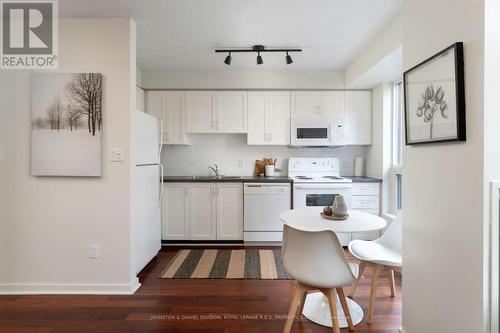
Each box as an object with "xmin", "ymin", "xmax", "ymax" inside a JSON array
[{"xmin": 281, "ymin": 224, "xmax": 357, "ymax": 333}]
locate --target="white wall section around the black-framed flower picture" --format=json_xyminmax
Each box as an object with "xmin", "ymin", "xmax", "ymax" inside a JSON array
[{"xmin": 402, "ymin": 0, "xmax": 484, "ymax": 333}]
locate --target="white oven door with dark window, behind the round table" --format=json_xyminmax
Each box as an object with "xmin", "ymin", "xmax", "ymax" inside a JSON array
[{"xmin": 293, "ymin": 183, "xmax": 352, "ymax": 209}]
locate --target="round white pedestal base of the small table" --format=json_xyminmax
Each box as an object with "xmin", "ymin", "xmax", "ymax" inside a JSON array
[{"xmin": 302, "ymin": 292, "xmax": 364, "ymax": 328}]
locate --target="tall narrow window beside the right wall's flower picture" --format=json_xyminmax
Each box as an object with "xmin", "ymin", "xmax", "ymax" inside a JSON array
[{"xmin": 391, "ymin": 81, "xmax": 404, "ymax": 212}]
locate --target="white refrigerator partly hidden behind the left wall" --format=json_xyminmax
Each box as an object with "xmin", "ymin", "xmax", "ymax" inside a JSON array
[{"xmin": 132, "ymin": 111, "xmax": 163, "ymax": 273}]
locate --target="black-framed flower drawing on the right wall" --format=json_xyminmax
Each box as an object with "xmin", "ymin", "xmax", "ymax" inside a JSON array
[{"xmin": 403, "ymin": 42, "xmax": 466, "ymax": 145}]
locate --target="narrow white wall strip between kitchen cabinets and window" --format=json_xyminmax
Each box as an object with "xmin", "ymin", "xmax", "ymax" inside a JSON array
[{"xmin": 366, "ymin": 83, "xmax": 392, "ymax": 213}]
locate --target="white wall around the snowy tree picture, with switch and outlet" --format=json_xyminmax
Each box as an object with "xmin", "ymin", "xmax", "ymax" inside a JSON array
[{"xmin": 0, "ymin": 18, "xmax": 137, "ymax": 293}]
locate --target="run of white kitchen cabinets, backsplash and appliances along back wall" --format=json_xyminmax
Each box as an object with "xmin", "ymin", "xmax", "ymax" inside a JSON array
[{"xmin": 138, "ymin": 88, "xmax": 382, "ymax": 246}]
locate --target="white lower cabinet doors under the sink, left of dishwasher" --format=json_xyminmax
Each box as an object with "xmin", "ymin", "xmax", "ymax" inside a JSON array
[{"xmin": 162, "ymin": 183, "xmax": 243, "ymax": 240}]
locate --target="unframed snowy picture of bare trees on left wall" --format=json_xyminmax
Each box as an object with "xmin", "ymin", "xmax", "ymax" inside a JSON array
[{"xmin": 31, "ymin": 73, "xmax": 103, "ymax": 177}]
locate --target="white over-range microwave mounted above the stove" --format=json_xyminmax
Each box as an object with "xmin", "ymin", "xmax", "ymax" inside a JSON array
[{"xmin": 290, "ymin": 120, "xmax": 345, "ymax": 146}]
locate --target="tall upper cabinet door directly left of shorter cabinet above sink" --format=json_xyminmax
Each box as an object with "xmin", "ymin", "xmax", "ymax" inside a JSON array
[{"xmin": 162, "ymin": 92, "xmax": 186, "ymax": 144}]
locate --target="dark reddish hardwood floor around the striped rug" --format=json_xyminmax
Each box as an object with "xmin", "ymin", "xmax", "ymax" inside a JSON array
[{"xmin": 0, "ymin": 248, "xmax": 401, "ymax": 333}]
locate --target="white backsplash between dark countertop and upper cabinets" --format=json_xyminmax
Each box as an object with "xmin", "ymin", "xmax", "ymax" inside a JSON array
[{"xmin": 162, "ymin": 134, "xmax": 366, "ymax": 176}]
